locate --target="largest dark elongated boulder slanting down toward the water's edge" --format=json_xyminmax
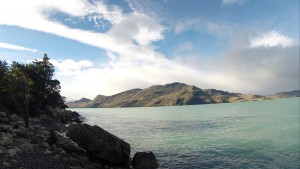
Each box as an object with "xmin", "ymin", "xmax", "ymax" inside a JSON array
[{"xmin": 68, "ymin": 124, "xmax": 130, "ymax": 165}]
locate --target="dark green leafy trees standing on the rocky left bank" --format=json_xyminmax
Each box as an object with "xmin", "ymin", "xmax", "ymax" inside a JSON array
[{"xmin": 0, "ymin": 54, "xmax": 67, "ymax": 127}]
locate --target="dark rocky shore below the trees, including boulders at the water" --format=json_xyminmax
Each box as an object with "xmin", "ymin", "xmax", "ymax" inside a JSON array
[{"xmin": 0, "ymin": 109, "xmax": 158, "ymax": 169}]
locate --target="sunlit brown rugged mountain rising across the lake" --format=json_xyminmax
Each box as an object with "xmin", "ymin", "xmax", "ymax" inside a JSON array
[{"xmin": 67, "ymin": 83, "xmax": 272, "ymax": 108}]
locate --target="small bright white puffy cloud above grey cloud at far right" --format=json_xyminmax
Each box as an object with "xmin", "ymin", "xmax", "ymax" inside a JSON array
[{"xmin": 250, "ymin": 31, "xmax": 296, "ymax": 48}]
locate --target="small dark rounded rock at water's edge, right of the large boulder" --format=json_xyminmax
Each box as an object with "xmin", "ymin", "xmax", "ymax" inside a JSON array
[{"xmin": 132, "ymin": 151, "xmax": 158, "ymax": 169}]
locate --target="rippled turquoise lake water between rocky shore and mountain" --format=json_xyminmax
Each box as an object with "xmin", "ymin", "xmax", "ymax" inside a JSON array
[{"xmin": 72, "ymin": 98, "xmax": 300, "ymax": 169}]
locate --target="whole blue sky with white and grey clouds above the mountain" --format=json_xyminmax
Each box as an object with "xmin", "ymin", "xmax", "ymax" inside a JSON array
[{"xmin": 0, "ymin": 0, "xmax": 299, "ymax": 101}]
